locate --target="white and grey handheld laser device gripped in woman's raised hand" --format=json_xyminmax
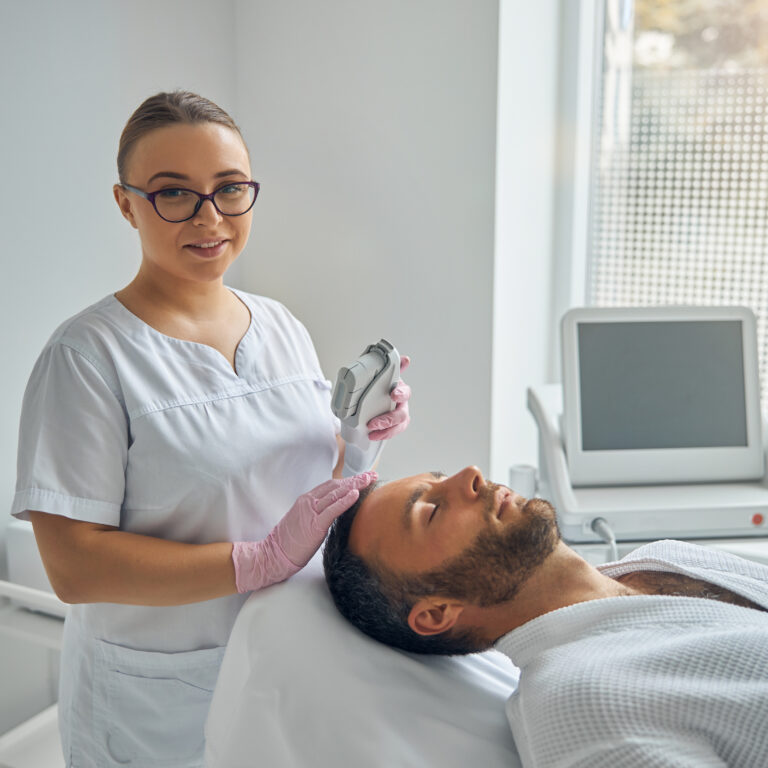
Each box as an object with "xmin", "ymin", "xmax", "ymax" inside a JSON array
[{"xmin": 331, "ymin": 339, "xmax": 400, "ymax": 477}]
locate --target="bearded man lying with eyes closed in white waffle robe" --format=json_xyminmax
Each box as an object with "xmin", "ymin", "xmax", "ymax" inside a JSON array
[{"xmin": 323, "ymin": 467, "xmax": 768, "ymax": 768}]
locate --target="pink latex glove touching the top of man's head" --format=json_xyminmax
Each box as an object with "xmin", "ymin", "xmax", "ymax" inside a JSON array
[{"xmin": 232, "ymin": 472, "xmax": 377, "ymax": 592}]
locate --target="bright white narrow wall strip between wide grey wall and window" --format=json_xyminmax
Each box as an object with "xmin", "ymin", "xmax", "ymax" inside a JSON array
[{"xmin": 491, "ymin": 0, "xmax": 560, "ymax": 483}]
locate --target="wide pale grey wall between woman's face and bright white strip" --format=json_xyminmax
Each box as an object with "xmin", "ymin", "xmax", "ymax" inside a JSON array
[{"xmin": 231, "ymin": 0, "xmax": 498, "ymax": 477}]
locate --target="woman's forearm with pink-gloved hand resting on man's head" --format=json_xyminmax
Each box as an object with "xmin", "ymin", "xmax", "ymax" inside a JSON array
[{"xmin": 29, "ymin": 472, "xmax": 376, "ymax": 605}]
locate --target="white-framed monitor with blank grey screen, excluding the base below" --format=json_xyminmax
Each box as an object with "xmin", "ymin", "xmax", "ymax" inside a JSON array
[{"xmin": 562, "ymin": 307, "xmax": 764, "ymax": 486}]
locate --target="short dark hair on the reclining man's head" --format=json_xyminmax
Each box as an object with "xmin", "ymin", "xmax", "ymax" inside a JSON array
[{"xmin": 323, "ymin": 486, "xmax": 488, "ymax": 656}]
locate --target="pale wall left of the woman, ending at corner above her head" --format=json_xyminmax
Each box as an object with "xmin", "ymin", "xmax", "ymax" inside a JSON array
[{"xmin": 0, "ymin": 0, "xmax": 235, "ymax": 733}]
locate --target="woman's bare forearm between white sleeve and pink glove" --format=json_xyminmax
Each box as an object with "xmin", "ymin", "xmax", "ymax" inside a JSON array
[{"xmin": 29, "ymin": 511, "xmax": 237, "ymax": 605}]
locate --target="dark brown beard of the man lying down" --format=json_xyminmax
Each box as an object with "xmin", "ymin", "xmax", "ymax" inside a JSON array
[{"xmin": 400, "ymin": 496, "xmax": 560, "ymax": 607}]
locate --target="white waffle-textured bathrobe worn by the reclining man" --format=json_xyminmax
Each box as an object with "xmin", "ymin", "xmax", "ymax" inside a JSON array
[{"xmin": 496, "ymin": 541, "xmax": 768, "ymax": 768}]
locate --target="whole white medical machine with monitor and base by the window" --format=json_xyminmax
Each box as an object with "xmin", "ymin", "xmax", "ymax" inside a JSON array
[{"xmin": 528, "ymin": 307, "xmax": 768, "ymax": 543}]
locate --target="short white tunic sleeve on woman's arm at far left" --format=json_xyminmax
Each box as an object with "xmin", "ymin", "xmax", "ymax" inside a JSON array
[{"xmin": 11, "ymin": 342, "xmax": 129, "ymax": 526}]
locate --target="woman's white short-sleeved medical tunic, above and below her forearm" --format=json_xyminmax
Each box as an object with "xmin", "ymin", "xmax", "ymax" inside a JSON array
[{"xmin": 12, "ymin": 291, "xmax": 338, "ymax": 768}]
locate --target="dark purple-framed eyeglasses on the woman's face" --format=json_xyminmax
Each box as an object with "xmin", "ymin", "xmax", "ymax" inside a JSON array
[{"xmin": 121, "ymin": 181, "xmax": 260, "ymax": 224}]
